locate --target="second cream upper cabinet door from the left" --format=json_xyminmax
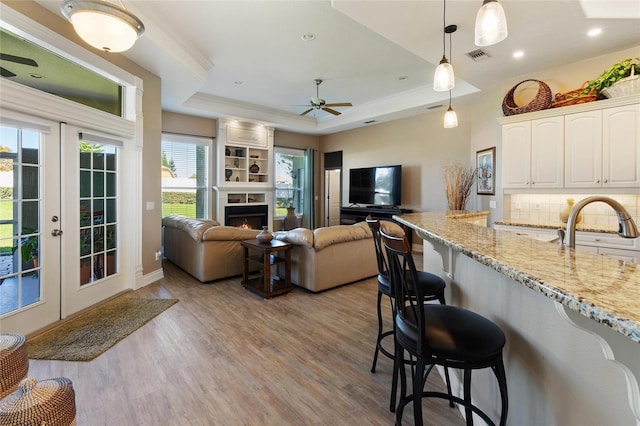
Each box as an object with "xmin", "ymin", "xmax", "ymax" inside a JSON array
[{"xmin": 531, "ymin": 116, "xmax": 564, "ymax": 188}]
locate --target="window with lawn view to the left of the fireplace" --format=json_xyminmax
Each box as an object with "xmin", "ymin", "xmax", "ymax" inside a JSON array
[{"xmin": 161, "ymin": 133, "xmax": 211, "ymax": 219}]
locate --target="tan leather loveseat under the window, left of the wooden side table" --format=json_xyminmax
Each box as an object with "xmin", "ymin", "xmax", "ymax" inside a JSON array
[{"xmin": 162, "ymin": 215, "xmax": 260, "ymax": 282}]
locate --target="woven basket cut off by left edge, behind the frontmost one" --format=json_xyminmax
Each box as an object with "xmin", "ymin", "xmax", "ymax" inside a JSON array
[{"xmin": 0, "ymin": 334, "xmax": 29, "ymax": 399}]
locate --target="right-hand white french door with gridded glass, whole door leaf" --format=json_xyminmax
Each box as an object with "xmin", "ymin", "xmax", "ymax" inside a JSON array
[{"xmin": 62, "ymin": 124, "xmax": 131, "ymax": 314}]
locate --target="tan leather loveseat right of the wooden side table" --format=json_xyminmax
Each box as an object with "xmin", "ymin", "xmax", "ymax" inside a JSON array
[{"xmin": 274, "ymin": 222, "xmax": 378, "ymax": 292}]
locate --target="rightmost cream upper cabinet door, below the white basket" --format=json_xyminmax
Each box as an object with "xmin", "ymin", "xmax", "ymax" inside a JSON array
[{"xmin": 602, "ymin": 105, "xmax": 640, "ymax": 188}]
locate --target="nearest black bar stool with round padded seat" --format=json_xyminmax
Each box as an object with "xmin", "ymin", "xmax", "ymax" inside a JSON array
[{"xmin": 381, "ymin": 229, "xmax": 508, "ymax": 426}]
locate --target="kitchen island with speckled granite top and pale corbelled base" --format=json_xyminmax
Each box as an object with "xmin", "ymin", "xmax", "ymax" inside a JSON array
[{"xmin": 394, "ymin": 212, "xmax": 640, "ymax": 425}]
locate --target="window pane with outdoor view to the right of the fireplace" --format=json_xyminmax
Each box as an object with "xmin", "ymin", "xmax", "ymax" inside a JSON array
[{"xmin": 274, "ymin": 147, "xmax": 305, "ymax": 216}]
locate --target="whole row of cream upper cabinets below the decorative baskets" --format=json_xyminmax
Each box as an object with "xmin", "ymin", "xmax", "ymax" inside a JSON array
[{"xmin": 499, "ymin": 96, "xmax": 640, "ymax": 189}]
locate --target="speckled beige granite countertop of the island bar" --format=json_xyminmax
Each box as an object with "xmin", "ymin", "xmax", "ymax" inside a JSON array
[{"xmin": 394, "ymin": 212, "xmax": 640, "ymax": 343}]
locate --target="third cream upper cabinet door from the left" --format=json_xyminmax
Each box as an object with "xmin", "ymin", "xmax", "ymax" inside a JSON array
[{"xmin": 564, "ymin": 111, "xmax": 602, "ymax": 188}]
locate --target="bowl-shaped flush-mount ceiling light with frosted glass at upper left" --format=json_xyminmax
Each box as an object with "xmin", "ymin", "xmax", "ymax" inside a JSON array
[{"xmin": 60, "ymin": 0, "xmax": 144, "ymax": 52}]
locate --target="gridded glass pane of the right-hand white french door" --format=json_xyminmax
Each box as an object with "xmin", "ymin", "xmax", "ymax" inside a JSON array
[{"xmin": 79, "ymin": 142, "xmax": 118, "ymax": 285}]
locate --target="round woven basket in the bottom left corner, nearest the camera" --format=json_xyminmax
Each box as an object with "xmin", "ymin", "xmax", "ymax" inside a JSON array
[{"xmin": 0, "ymin": 377, "xmax": 76, "ymax": 426}]
